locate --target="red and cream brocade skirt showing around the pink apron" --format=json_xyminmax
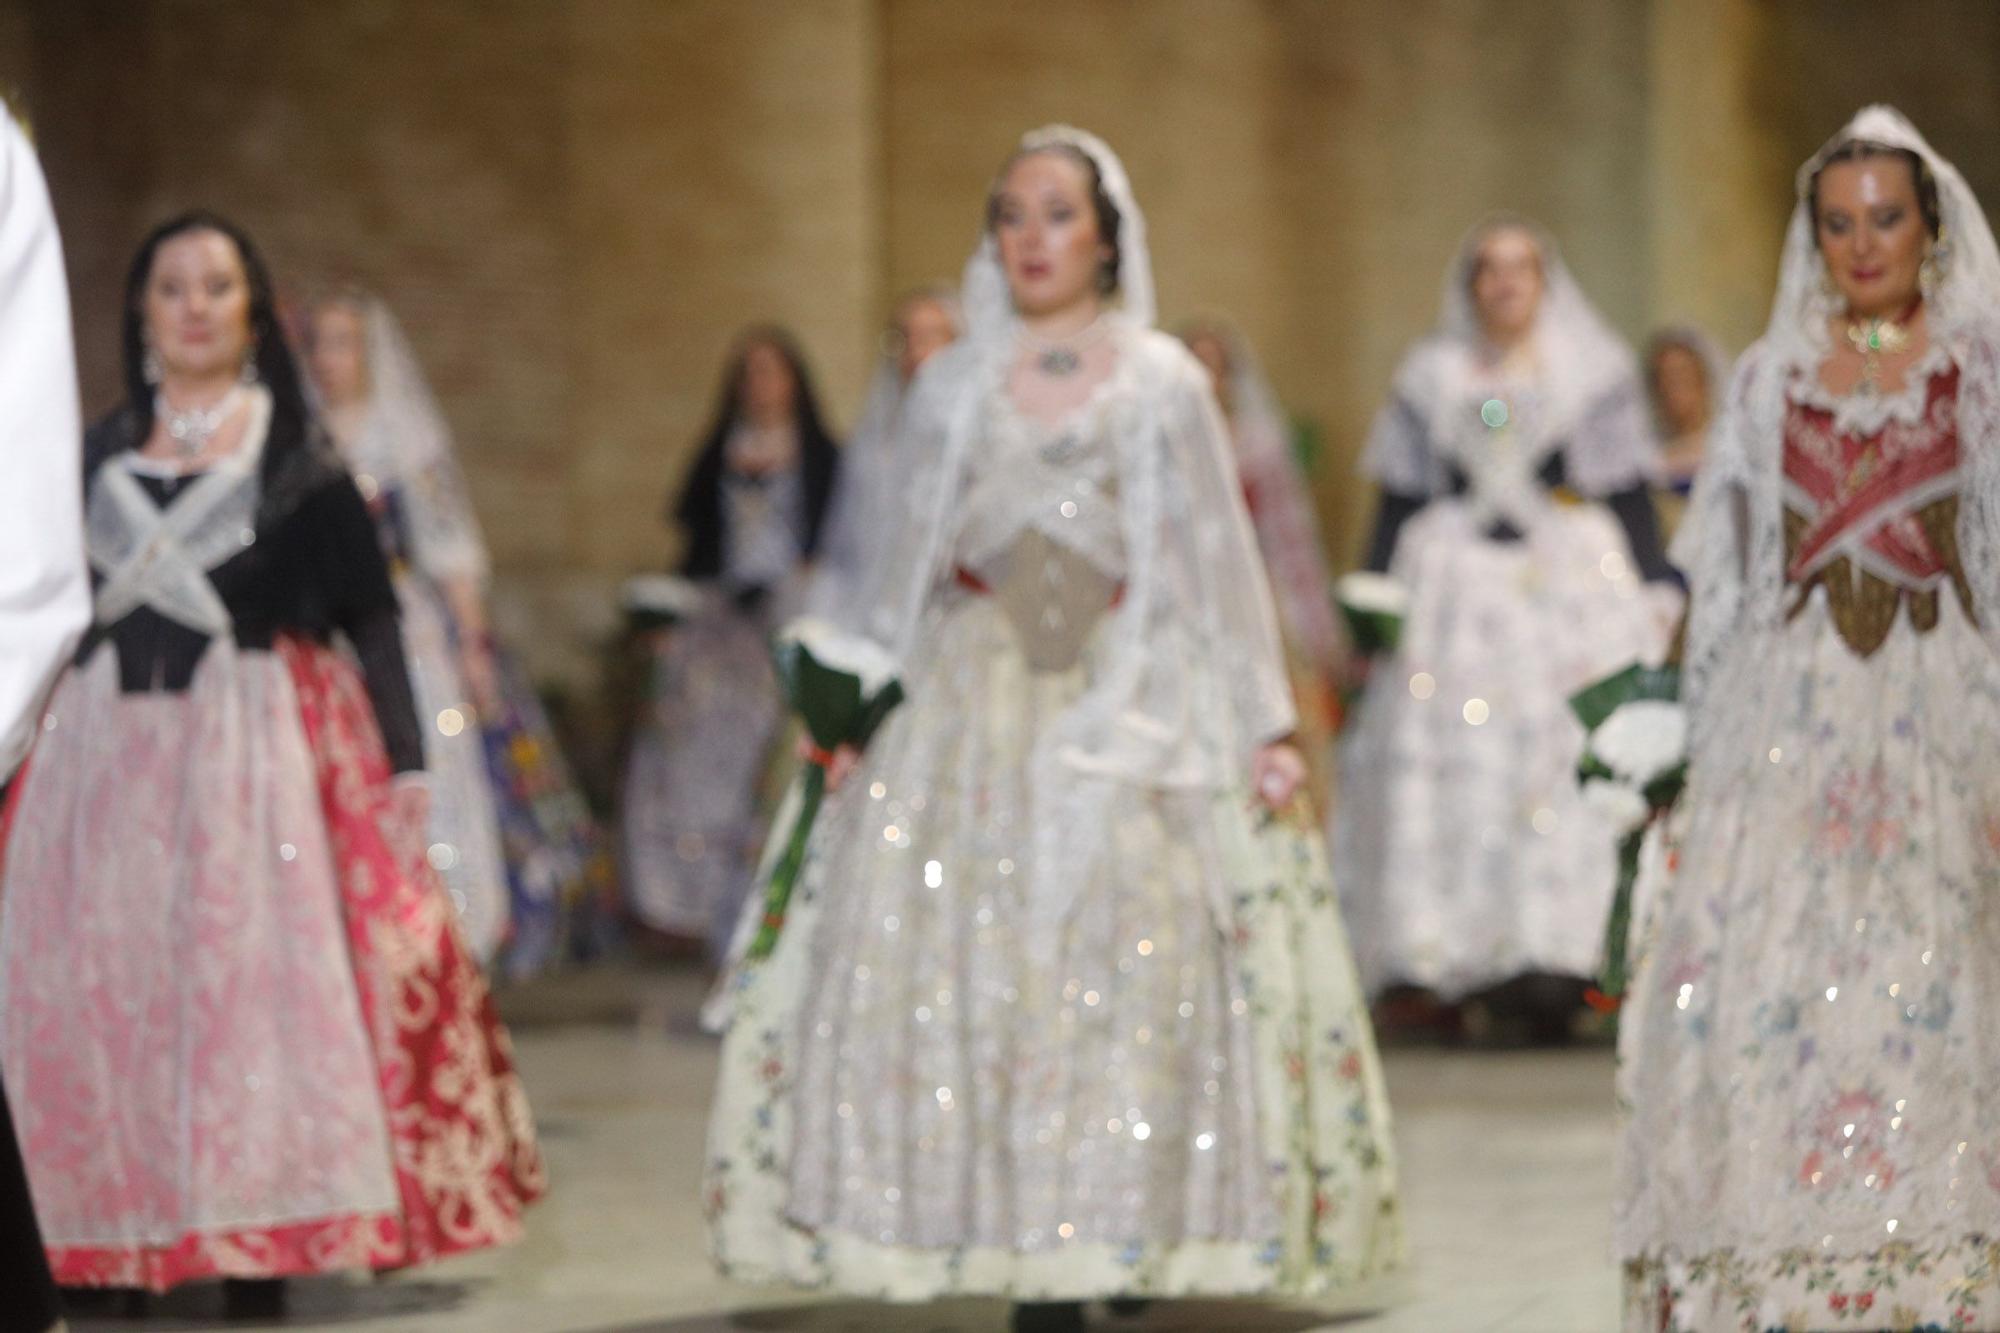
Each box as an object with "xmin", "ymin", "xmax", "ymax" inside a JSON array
[{"xmin": 0, "ymin": 640, "xmax": 546, "ymax": 1291}]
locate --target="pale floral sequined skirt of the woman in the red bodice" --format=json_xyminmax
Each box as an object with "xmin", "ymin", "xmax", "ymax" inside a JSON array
[{"xmin": 1618, "ymin": 592, "xmax": 2000, "ymax": 1333}]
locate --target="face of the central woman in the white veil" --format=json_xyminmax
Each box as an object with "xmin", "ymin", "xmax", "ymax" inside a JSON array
[{"xmin": 994, "ymin": 152, "xmax": 1112, "ymax": 318}]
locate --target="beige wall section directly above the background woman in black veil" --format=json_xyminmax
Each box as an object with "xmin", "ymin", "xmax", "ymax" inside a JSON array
[{"xmin": 552, "ymin": 0, "xmax": 882, "ymax": 574}]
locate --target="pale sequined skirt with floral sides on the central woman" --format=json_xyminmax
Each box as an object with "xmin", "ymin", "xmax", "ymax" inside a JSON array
[{"xmin": 706, "ymin": 598, "xmax": 1402, "ymax": 1301}]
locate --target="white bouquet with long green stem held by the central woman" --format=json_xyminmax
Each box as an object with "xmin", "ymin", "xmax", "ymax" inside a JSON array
[{"xmin": 746, "ymin": 616, "xmax": 902, "ymax": 959}]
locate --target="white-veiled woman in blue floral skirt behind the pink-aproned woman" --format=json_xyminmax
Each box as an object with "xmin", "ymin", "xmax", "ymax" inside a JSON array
[{"xmin": 306, "ymin": 290, "xmax": 606, "ymax": 977}]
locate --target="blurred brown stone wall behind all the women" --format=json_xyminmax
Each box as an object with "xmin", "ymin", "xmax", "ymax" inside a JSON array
[{"xmin": 0, "ymin": 0, "xmax": 2000, "ymax": 675}]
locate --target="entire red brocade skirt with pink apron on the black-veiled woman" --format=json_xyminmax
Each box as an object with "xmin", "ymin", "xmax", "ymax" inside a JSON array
[{"xmin": 0, "ymin": 640, "xmax": 544, "ymax": 1291}]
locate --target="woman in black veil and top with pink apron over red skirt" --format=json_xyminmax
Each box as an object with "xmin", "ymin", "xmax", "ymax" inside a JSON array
[{"xmin": 0, "ymin": 214, "xmax": 540, "ymax": 1311}]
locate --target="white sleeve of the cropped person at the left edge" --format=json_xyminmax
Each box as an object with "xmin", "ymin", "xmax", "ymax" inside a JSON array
[{"xmin": 0, "ymin": 112, "xmax": 90, "ymax": 779}]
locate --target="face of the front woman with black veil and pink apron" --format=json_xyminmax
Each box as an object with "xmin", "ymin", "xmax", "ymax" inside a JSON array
[{"xmin": 140, "ymin": 230, "xmax": 250, "ymax": 380}]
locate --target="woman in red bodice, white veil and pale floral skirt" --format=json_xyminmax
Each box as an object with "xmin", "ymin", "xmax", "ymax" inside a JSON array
[{"xmin": 1616, "ymin": 106, "xmax": 2000, "ymax": 1333}]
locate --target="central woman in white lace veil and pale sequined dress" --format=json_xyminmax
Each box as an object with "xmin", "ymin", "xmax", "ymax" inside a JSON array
[{"xmin": 708, "ymin": 128, "xmax": 1400, "ymax": 1333}]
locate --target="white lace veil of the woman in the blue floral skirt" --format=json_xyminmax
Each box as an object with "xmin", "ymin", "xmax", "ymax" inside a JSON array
[{"xmin": 332, "ymin": 292, "xmax": 488, "ymax": 582}]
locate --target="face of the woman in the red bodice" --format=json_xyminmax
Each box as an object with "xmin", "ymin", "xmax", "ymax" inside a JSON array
[{"xmin": 1818, "ymin": 156, "xmax": 1930, "ymax": 318}]
